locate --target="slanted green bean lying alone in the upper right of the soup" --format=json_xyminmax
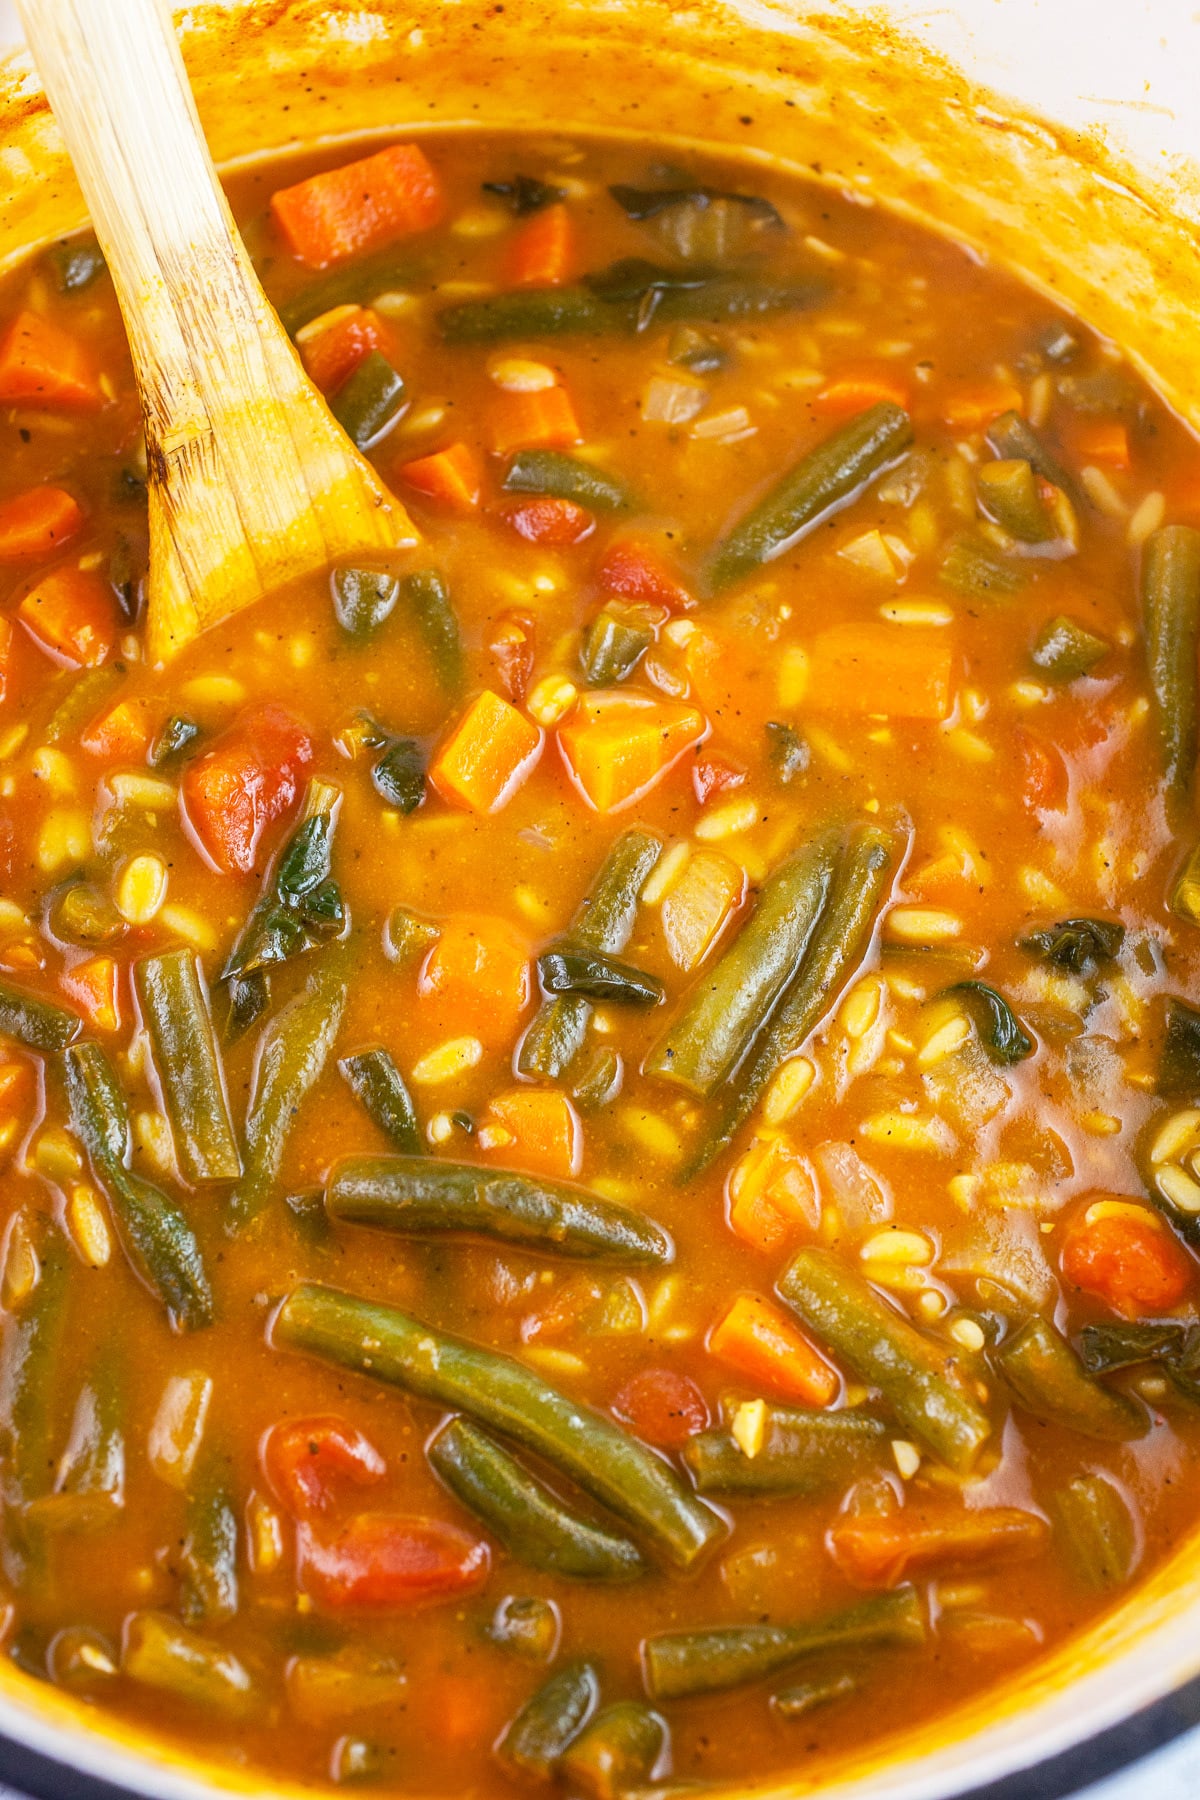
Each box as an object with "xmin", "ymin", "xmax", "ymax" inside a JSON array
[{"xmin": 709, "ymin": 401, "xmax": 912, "ymax": 592}]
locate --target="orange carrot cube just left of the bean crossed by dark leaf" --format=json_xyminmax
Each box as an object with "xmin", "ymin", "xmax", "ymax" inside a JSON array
[{"xmin": 417, "ymin": 913, "xmax": 531, "ymax": 1044}]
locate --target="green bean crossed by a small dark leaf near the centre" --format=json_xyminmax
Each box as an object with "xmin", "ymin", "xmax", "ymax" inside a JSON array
[{"xmin": 516, "ymin": 832, "xmax": 662, "ymax": 1080}]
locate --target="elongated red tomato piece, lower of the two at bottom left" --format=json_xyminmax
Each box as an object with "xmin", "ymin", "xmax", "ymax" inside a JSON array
[{"xmin": 295, "ymin": 1512, "xmax": 491, "ymax": 1611}]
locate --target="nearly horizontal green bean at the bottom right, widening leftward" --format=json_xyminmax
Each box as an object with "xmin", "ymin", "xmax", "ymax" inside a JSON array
[{"xmin": 642, "ymin": 1588, "xmax": 925, "ymax": 1699}]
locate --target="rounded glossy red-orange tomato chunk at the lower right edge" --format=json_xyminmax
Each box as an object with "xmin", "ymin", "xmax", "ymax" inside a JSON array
[{"xmin": 1061, "ymin": 1195, "xmax": 1196, "ymax": 1319}]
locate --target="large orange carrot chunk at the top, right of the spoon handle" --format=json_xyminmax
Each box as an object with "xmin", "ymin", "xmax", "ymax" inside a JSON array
[{"xmin": 272, "ymin": 144, "xmax": 444, "ymax": 268}]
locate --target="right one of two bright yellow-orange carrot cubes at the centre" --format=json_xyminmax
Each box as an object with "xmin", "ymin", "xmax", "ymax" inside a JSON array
[{"xmin": 558, "ymin": 689, "xmax": 709, "ymax": 812}]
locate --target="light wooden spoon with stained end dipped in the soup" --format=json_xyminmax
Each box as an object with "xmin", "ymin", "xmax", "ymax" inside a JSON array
[{"xmin": 18, "ymin": 0, "xmax": 416, "ymax": 662}]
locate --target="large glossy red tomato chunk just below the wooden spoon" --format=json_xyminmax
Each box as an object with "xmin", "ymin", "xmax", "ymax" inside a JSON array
[{"xmin": 182, "ymin": 706, "xmax": 313, "ymax": 875}]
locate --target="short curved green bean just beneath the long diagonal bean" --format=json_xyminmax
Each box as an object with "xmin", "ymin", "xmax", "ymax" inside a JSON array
[{"xmin": 426, "ymin": 1418, "xmax": 646, "ymax": 1582}]
